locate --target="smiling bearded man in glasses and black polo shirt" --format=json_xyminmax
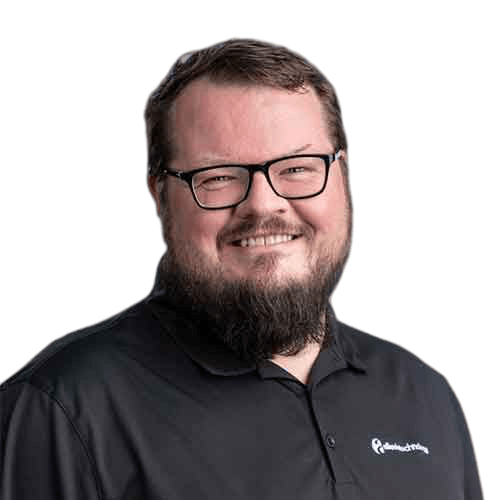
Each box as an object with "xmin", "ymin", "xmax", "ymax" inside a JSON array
[{"xmin": 0, "ymin": 38, "xmax": 483, "ymax": 500}]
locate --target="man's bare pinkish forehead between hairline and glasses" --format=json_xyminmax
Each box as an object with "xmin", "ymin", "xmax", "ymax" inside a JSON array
[{"xmin": 171, "ymin": 80, "xmax": 331, "ymax": 167}]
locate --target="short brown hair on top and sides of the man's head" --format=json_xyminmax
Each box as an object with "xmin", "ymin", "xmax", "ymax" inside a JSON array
[{"xmin": 142, "ymin": 37, "xmax": 350, "ymax": 184}]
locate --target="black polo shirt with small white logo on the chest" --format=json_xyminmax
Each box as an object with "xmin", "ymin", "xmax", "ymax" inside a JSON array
[{"xmin": 0, "ymin": 298, "xmax": 484, "ymax": 500}]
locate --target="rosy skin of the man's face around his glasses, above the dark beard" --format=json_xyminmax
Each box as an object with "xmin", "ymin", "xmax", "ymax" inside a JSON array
[{"xmin": 152, "ymin": 80, "xmax": 349, "ymax": 285}]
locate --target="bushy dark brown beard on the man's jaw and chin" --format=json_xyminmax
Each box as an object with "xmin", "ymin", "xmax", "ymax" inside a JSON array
[{"xmin": 159, "ymin": 217, "xmax": 350, "ymax": 365}]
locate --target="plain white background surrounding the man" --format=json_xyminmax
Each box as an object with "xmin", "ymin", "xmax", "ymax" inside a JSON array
[{"xmin": 0, "ymin": 1, "xmax": 500, "ymax": 498}]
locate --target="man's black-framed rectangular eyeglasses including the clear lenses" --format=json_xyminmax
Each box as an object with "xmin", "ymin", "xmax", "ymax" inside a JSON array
[{"xmin": 159, "ymin": 149, "xmax": 340, "ymax": 210}]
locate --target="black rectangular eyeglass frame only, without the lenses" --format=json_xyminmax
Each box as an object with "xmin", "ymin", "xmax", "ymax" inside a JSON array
[{"xmin": 158, "ymin": 148, "xmax": 340, "ymax": 210}]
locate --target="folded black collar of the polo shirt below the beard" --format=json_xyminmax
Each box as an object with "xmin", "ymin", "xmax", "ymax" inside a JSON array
[{"xmin": 146, "ymin": 292, "xmax": 366, "ymax": 384}]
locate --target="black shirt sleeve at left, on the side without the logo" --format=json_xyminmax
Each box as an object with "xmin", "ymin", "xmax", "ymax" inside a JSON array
[{"xmin": 0, "ymin": 383, "xmax": 102, "ymax": 500}]
